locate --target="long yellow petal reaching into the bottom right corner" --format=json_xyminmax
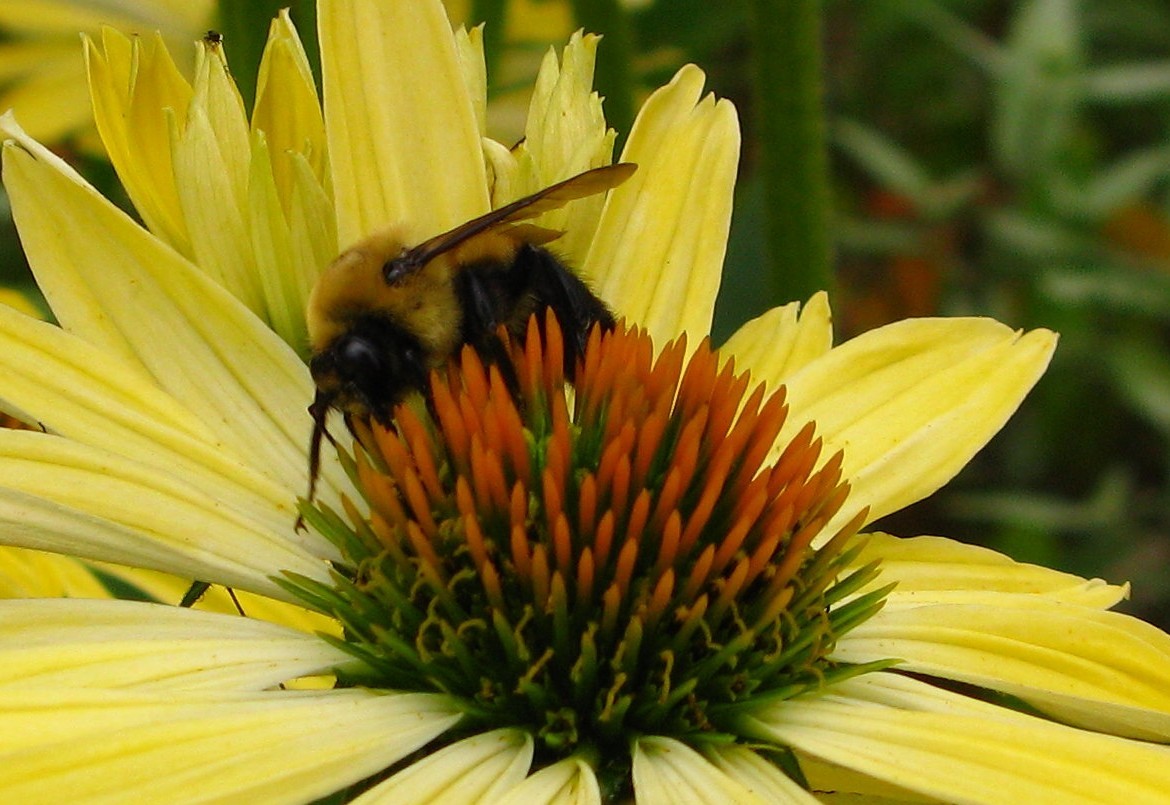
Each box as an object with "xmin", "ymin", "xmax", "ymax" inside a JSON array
[{"xmin": 743, "ymin": 673, "xmax": 1170, "ymax": 804}]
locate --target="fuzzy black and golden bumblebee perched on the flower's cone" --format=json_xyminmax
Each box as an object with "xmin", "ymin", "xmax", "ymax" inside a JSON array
[{"xmin": 308, "ymin": 163, "xmax": 636, "ymax": 500}]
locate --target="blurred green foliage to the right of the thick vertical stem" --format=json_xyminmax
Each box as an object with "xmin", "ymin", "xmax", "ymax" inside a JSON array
[{"xmin": 828, "ymin": 0, "xmax": 1170, "ymax": 624}]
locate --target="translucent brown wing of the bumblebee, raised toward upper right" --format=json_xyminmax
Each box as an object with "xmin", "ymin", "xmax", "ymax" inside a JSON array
[{"xmin": 386, "ymin": 163, "xmax": 638, "ymax": 281}]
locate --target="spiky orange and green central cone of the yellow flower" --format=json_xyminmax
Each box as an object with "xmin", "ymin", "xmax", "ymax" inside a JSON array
[{"xmin": 290, "ymin": 316, "xmax": 881, "ymax": 790}]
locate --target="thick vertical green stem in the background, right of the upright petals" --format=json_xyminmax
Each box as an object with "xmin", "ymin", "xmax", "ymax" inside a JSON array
[{"xmin": 749, "ymin": 0, "xmax": 833, "ymax": 303}]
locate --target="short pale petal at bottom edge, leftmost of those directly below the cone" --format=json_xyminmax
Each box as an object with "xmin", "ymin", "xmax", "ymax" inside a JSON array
[{"xmin": 353, "ymin": 729, "xmax": 534, "ymax": 805}]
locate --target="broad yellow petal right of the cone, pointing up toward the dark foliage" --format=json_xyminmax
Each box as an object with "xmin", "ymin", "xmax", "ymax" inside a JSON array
[{"xmin": 772, "ymin": 318, "xmax": 1057, "ymax": 532}]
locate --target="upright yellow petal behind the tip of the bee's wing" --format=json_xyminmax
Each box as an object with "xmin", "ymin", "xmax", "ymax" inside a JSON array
[{"xmin": 583, "ymin": 66, "xmax": 739, "ymax": 349}]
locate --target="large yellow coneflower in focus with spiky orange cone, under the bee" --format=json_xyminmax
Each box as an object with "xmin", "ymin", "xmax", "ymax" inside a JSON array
[{"xmin": 0, "ymin": 0, "xmax": 1170, "ymax": 803}]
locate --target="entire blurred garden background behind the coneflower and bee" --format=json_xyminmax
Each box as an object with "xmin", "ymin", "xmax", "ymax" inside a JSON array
[{"xmin": 0, "ymin": 0, "xmax": 1170, "ymax": 628}]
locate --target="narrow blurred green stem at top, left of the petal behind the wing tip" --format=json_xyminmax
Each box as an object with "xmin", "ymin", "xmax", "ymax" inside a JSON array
[{"xmin": 572, "ymin": 0, "xmax": 634, "ymax": 153}]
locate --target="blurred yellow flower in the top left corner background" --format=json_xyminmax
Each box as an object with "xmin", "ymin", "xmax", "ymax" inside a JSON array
[{"xmin": 0, "ymin": 0, "xmax": 214, "ymax": 142}]
